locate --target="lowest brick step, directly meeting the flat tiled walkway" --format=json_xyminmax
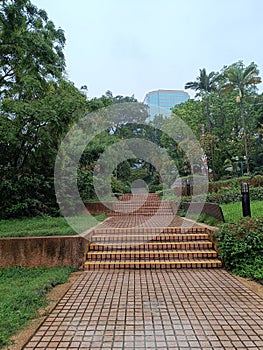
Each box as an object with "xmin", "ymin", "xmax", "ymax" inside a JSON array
[{"xmin": 84, "ymin": 259, "xmax": 222, "ymax": 270}]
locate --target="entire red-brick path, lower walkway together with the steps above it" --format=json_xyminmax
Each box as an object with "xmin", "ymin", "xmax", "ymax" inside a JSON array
[{"xmin": 24, "ymin": 194, "xmax": 263, "ymax": 350}]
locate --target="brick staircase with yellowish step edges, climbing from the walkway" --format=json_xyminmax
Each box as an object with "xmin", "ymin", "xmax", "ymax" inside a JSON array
[{"xmin": 84, "ymin": 195, "xmax": 222, "ymax": 270}]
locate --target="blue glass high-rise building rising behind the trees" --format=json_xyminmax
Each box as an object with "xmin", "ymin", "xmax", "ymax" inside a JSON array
[{"xmin": 143, "ymin": 90, "xmax": 190, "ymax": 120}]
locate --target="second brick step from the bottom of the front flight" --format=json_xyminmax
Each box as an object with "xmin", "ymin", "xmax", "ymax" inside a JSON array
[{"xmin": 87, "ymin": 249, "xmax": 217, "ymax": 261}]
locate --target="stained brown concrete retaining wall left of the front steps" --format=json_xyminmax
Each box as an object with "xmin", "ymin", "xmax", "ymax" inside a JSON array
[{"xmin": 0, "ymin": 236, "xmax": 88, "ymax": 268}]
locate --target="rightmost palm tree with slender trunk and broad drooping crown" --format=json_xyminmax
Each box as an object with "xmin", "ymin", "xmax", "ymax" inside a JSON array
[{"xmin": 222, "ymin": 61, "xmax": 261, "ymax": 174}]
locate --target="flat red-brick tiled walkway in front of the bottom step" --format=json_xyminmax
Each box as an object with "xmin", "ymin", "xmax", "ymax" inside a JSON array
[{"xmin": 24, "ymin": 269, "xmax": 263, "ymax": 350}]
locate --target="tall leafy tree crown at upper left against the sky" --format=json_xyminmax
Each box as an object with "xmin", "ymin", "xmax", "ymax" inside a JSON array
[{"xmin": 0, "ymin": 0, "xmax": 65, "ymax": 98}]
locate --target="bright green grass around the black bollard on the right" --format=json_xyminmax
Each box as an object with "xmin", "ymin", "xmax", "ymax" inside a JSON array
[{"xmin": 220, "ymin": 201, "xmax": 263, "ymax": 223}]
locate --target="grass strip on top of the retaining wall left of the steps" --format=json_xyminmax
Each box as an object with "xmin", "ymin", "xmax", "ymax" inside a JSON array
[{"xmin": 0, "ymin": 215, "xmax": 106, "ymax": 237}]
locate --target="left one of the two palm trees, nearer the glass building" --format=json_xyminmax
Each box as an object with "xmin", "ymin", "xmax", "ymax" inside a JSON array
[{"xmin": 185, "ymin": 68, "xmax": 220, "ymax": 178}]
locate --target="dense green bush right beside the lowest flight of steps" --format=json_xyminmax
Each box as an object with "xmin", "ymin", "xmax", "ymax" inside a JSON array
[{"xmin": 217, "ymin": 218, "xmax": 263, "ymax": 283}]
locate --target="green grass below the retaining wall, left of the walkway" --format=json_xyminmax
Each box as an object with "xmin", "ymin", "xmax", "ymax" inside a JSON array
[{"xmin": 0, "ymin": 267, "xmax": 73, "ymax": 347}]
